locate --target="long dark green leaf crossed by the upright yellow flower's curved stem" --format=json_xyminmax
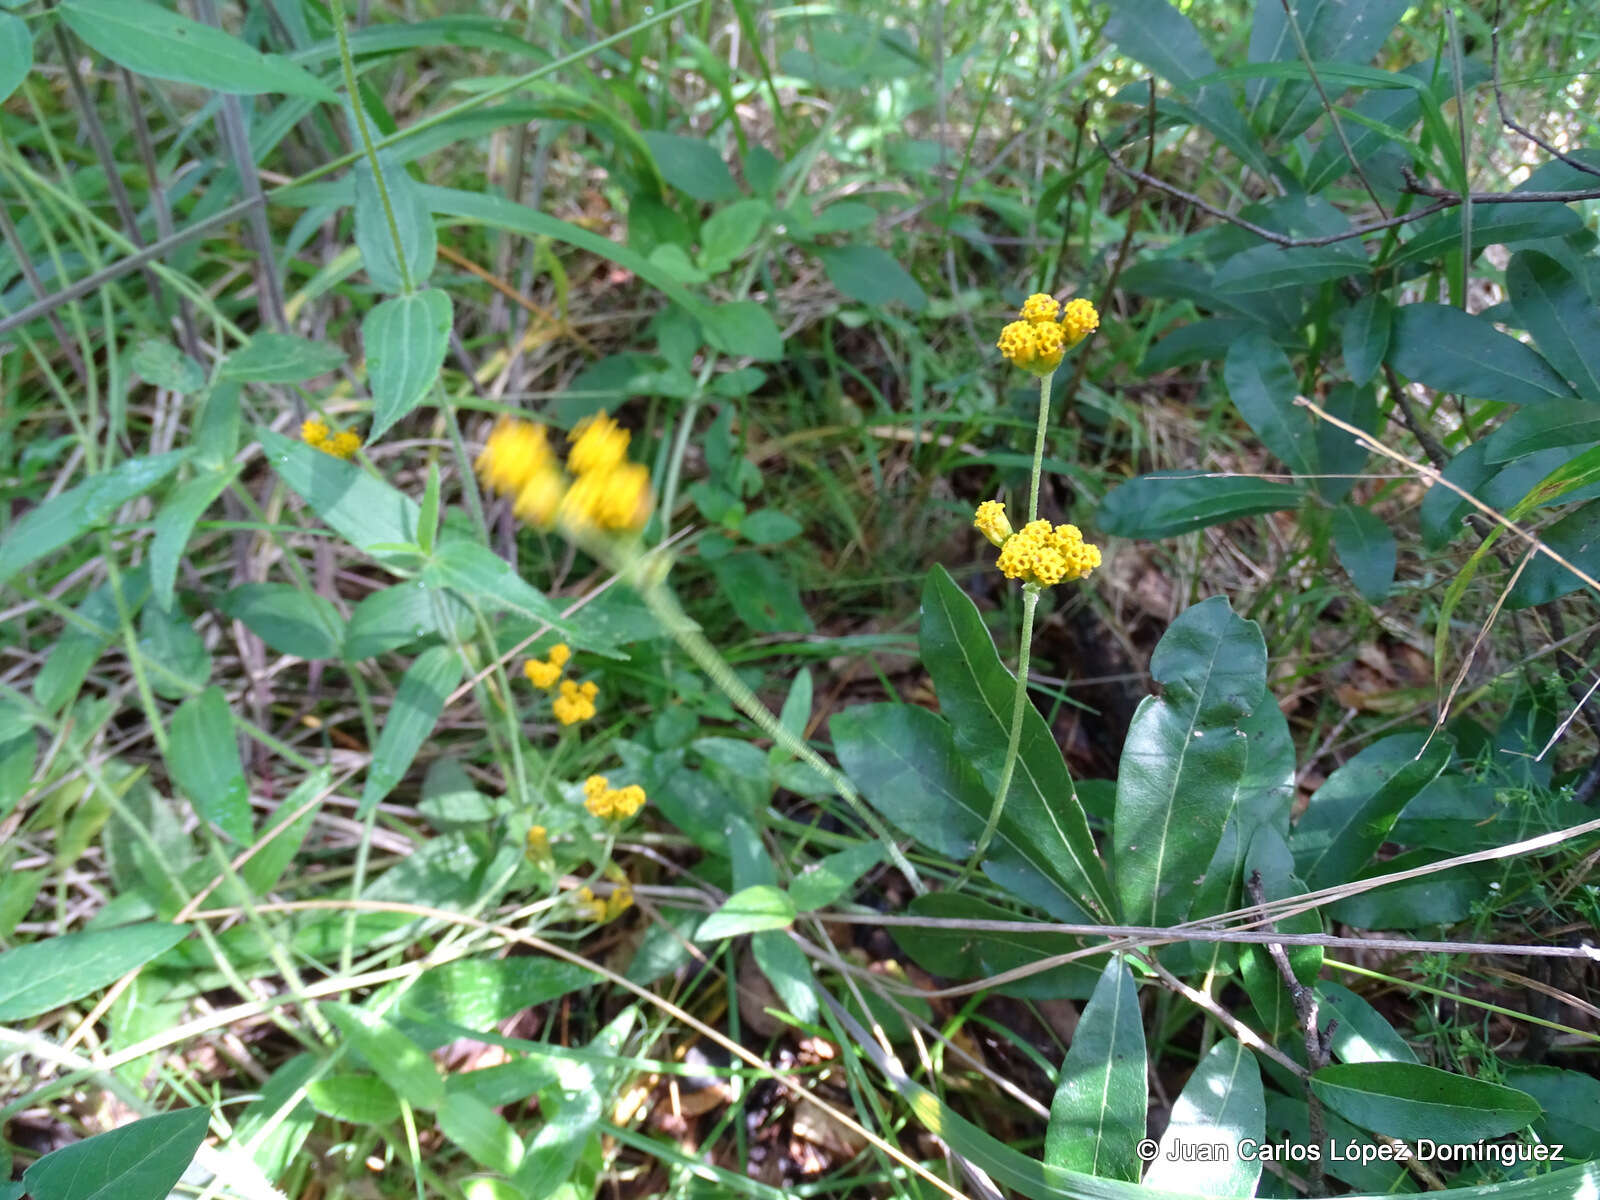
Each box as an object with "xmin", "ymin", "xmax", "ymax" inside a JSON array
[{"xmin": 918, "ymin": 566, "xmax": 1115, "ymax": 920}]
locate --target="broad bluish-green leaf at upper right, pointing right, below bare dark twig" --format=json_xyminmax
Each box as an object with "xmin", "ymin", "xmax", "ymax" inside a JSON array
[{"xmin": 1389, "ymin": 304, "xmax": 1573, "ymax": 405}]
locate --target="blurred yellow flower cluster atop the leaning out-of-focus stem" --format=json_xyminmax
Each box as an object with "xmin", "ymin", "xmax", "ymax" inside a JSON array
[{"xmin": 477, "ymin": 413, "xmax": 651, "ymax": 533}]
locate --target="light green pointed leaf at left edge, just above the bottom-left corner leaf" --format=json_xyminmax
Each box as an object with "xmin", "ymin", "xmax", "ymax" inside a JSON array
[{"xmin": 0, "ymin": 923, "xmax": 189, "ymax": 1021}]
